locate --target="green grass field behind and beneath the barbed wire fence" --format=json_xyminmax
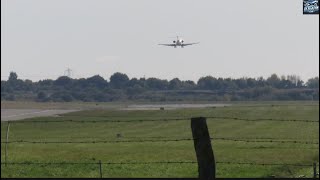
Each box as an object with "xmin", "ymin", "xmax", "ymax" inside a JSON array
[{"xmin": 1, "ymin": 102, "xmax": 319, "ymax": 177}]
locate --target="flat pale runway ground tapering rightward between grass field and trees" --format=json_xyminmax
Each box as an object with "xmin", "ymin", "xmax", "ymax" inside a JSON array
[{"xmin": 1, "ymin": 102, "xmax": 231, "ymax": 121}]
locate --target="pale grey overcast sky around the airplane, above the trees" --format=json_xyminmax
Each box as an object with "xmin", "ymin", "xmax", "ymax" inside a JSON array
[{"xmin": 1, "ymin": 0, "xmax": 319, "ymax": 81}]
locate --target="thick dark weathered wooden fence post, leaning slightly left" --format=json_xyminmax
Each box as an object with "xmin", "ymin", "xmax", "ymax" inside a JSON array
[{"xmin": 191, "ymin": 117, "xmax": 216, "ymax": 180}]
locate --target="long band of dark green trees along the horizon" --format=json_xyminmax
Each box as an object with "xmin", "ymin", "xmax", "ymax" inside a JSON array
[{"xmin": 1, "ymin": 72, "xmax": 319, "ymax": 102}]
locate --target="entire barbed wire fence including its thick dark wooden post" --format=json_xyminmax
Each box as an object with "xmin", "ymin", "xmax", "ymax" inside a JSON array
[{"xmin": 1, "ymin": 116, "xmax": 319, "ymax": 179}]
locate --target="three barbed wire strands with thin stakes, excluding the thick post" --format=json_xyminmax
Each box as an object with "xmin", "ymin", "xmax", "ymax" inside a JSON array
[{"xmin": 1, "ymin": 116, "xmax": 319, "ymax": 177}]
